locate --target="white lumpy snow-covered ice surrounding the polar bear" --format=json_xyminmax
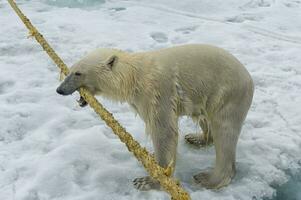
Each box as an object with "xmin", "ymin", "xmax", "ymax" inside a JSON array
[{"xmin": 0, "ymin": 0, "xmax": 301, "ymax": 200}]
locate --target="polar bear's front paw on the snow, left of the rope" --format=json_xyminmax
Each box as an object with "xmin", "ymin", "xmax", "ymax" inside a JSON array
[{"xmin": 133, "ymin": 176, "xmax": 161, "ymax": 191}]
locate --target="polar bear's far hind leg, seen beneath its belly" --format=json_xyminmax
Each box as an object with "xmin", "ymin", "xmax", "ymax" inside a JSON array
[{"xmin": 185, "ymin": 118, "xmax": 213, "ymax": 147}]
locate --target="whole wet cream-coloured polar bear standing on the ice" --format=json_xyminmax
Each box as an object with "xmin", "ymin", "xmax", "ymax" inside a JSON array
[{"xmin": 57, "ymin": 44, "xmax": 254, "ymax": 190}]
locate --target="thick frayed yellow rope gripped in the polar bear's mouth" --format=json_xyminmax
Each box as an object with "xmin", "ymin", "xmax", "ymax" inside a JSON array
[{"xmin": 8, "ymin": 0, "xmax": 190, "ymax": 200}]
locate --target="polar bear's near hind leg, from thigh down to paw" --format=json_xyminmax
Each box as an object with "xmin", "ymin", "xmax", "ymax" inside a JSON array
[{"xmin": 193, "ymin": 112, "xmax": 244, "ymax": 189}]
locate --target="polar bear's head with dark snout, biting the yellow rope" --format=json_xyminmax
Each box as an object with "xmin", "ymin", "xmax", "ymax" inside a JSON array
[{"xmin": 56, "ymin": 49, "xmax": 118, "ymax": 95}]
